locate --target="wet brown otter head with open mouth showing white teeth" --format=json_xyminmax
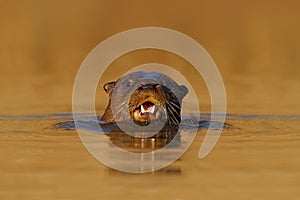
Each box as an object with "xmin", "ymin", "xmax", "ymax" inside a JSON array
[{"xmin": 101, "ymin": 71, "xmax": 188, "ymax": 126}]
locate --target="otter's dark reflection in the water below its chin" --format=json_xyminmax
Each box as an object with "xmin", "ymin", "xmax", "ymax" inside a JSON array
[{"xmin": 99, "ymin": 123, "xmax": 184, "ymax": 174}]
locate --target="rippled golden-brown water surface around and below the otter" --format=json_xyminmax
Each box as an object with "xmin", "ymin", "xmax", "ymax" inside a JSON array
[{"xmin": 0, "ymin": 114, "xmax": 300, "ymax": 199}]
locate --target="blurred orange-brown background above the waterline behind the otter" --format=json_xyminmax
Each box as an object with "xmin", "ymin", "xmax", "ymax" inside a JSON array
[{"xmin": 0, "ymin": 0, "xmax": 300, "ymax": 114}]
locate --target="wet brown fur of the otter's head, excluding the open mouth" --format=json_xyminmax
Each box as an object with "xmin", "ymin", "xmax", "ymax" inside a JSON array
[{"xmin": 101, "ymin": 71, "xmax": 188, "ymax": 126}]
